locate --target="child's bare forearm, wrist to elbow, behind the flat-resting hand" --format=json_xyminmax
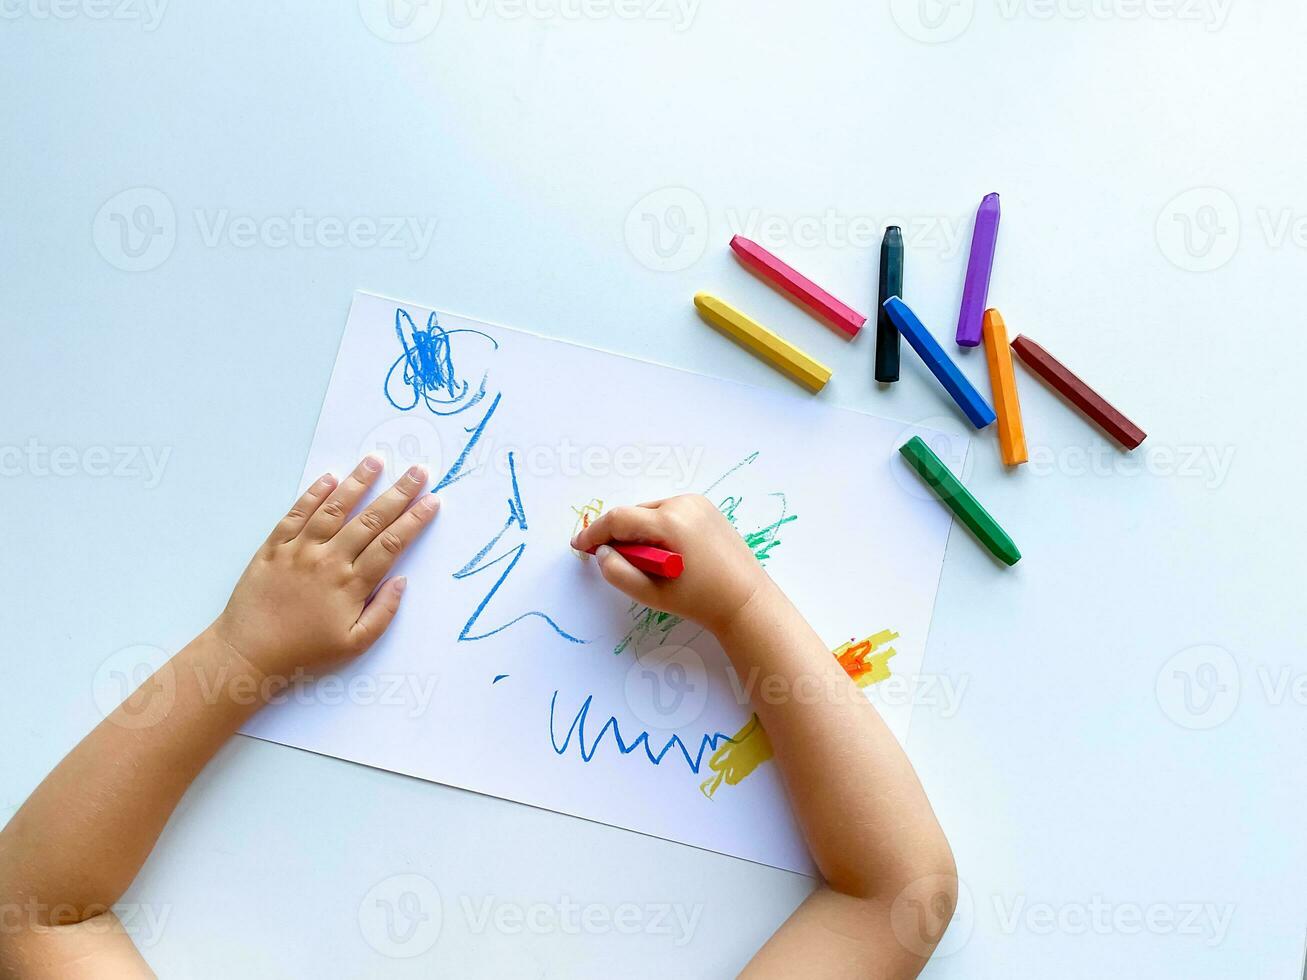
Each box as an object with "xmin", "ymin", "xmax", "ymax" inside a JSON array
[{"xmin": 0, "ymin": 630, "xmax": 267, "ymax": 925}]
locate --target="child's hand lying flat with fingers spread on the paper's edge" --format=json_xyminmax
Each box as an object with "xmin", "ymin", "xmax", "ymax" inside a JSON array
[{"xmin": 212, "ymin": 456, "xmax": 438, "ymax": 681}]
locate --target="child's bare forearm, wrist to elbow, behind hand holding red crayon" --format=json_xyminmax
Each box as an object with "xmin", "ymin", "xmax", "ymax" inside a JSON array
[{"xmin": 718, "ymin": 580, "xmax": 954, "ymax": 900}]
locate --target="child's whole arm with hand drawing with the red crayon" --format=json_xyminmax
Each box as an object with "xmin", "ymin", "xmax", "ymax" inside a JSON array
[{"xmin": 572, "ymin": 497, "xmax": 957, "ymax": 977}]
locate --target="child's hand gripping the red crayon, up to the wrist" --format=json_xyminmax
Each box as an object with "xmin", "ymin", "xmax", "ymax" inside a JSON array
[{"xmin": 572, "ymin": 494, "xmax": 771, "ymax": 635}]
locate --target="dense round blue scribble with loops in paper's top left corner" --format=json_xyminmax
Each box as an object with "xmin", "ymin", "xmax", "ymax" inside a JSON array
[{"xmin": 383, "ymin": 310, "xmax": 499, "ymax": 416}]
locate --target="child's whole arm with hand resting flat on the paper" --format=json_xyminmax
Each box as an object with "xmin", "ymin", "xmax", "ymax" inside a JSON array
[{"xmin": 0, "ymin": 457, "xmax": 437, "ymax": 980}]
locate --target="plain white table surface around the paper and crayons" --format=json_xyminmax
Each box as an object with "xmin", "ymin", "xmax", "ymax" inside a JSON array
[{"xmin": 0, "ymin": 0, "xmax": 1307, "ymax": 977}]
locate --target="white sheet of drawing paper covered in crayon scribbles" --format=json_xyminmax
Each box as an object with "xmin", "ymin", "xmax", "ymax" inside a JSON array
[{"xmin": 244, "ymin": 293, "xmax": 966, "ymax": 874}]
